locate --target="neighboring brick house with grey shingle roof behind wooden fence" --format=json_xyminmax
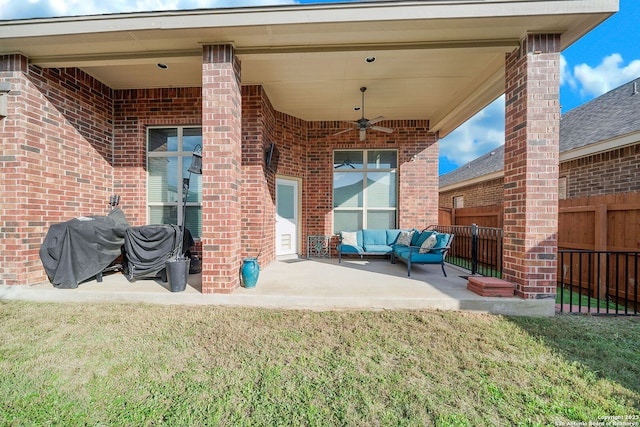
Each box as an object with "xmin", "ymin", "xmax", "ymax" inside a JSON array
[{"xmin": 440, "ymin": 78, "xmax": 640, "ymax": 208}]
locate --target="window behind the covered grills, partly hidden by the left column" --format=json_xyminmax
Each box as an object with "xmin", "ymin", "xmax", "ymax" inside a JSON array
[{"xmin": 147, "ymin": 127, "xmax": 202, "ymax": 237}]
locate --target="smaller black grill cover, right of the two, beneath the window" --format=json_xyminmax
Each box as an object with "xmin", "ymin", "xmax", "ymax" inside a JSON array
[{"xmin": 124, "ymin": 225, "xmax": 194, "ymax": 280}]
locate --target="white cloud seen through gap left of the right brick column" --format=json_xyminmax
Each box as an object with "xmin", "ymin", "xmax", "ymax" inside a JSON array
[{"xmin": 440, "ymin": 95, "xmax": 504, "ymax": 170}]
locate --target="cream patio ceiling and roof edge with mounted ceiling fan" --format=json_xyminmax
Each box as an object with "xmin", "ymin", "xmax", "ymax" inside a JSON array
[{"xmin": 0, "ymin": 0, "xmax": 618, "ymax": 136}]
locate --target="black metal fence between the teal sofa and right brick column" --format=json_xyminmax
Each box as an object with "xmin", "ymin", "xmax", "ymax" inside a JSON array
[{"xmin": 429, "ymin": 224, "xmax": 503, "ymax": 277}]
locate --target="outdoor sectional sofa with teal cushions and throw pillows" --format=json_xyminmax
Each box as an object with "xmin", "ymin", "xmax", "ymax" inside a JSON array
[{"xmin": 336, "ymin": 229, "xmax": 453, "ymax": 277}]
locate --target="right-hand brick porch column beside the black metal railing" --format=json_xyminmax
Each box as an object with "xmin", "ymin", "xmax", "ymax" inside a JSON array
[{"xmin": 503, "ymin": 34, "xmax": 560, "ymax": 299}]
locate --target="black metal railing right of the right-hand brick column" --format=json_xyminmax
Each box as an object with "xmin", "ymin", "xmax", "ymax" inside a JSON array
[{"xmin": 557, "ymin": 249, "xmax": 640, "ymax": 316}]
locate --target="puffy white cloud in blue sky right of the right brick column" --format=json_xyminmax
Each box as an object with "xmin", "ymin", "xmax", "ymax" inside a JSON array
[{"xmin": 573, "ymin": 53, "xmax": 640, "ymax": 98}]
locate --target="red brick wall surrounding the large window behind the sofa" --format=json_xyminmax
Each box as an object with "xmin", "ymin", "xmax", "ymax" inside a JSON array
[{"xmin": 304, "ymin": 120, "xmax": 438, "ymax": 237}]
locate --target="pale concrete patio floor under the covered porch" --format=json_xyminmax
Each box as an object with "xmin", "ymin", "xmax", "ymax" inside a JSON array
[{"xmin": 0, "ymin": 258, "xmax": 555, "ymax": 316}]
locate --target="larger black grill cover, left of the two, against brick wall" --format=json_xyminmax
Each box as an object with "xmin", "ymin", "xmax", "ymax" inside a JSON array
[{"xmin": 40, "ymin": 208, "xmax": 129, "ymax": 289}]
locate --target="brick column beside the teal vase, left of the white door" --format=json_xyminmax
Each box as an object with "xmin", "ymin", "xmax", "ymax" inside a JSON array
[{"xmin": 202, "ymin": 45, "xmax": 242, "ymax": 293}]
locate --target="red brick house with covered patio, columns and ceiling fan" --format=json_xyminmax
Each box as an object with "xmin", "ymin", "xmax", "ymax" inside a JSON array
[{"xmin": 0, "ymin": 0, "xmax": 618, "ymax": 298}]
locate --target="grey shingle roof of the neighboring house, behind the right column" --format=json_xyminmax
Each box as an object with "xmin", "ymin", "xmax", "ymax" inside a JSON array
[{"xmin": 440, "ymin": 78, "xmax": 640, "ymax": 191}]
